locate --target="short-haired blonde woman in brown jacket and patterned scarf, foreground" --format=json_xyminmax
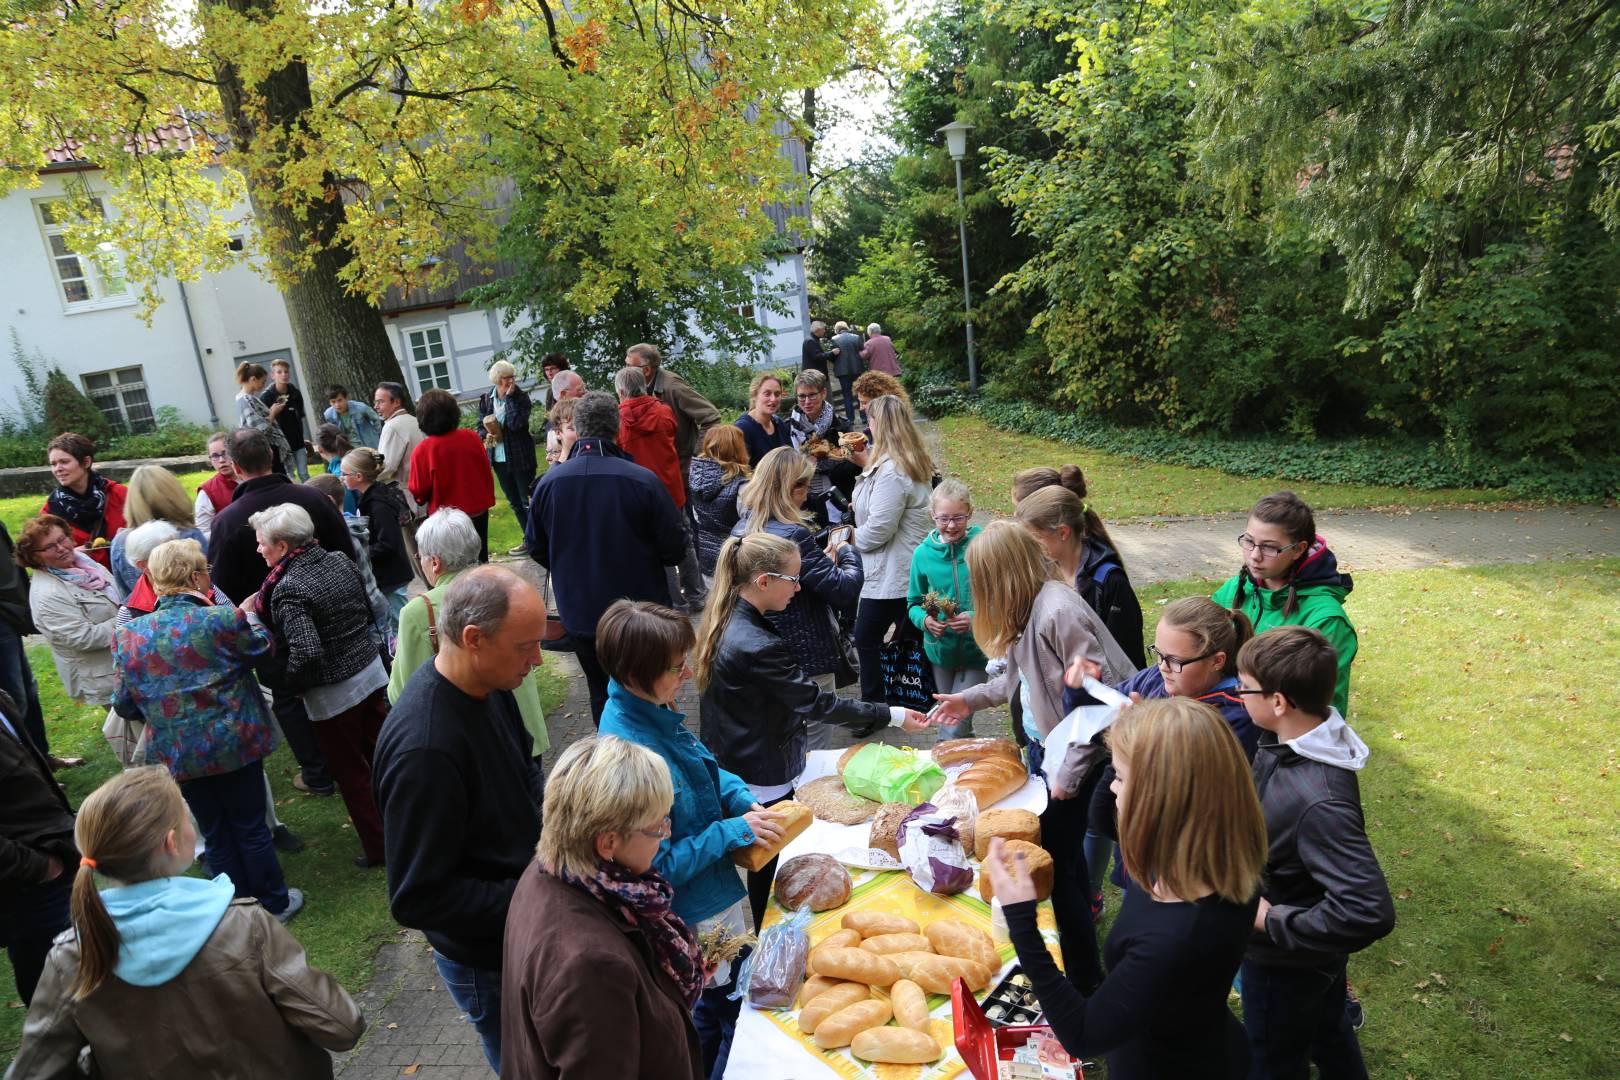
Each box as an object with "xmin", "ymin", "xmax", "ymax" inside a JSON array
[{"xmin": 501, "ymin": 737, "xmax": 706, "ymax": 1080}]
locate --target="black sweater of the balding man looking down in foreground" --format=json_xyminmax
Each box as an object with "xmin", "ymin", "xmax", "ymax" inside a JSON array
[{"xmin": 371, "ymin": 661, "xmax": 544, "ymax": 972}]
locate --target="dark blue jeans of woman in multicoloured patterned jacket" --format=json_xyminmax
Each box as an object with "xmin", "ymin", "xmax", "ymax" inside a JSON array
[{"xmin": 180, "ymin": 761, "xmax": 287, "ymax": 915}]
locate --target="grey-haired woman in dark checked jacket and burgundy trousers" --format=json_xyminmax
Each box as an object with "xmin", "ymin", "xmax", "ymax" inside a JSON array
[{"xmin": 241, "ymin": 502, "xmax": 389, "ymax": 868}]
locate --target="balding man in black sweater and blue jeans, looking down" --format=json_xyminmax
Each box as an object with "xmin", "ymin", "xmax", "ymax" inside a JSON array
[{"xmin": 371, "ymin": 567, "xmax": 546, "ymax": 1072}]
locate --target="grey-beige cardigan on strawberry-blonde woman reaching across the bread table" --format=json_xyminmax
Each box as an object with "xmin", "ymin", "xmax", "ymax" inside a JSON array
[{"xmin": 962, "ymin": 581, "xmax": 1136, "ymax": 793}]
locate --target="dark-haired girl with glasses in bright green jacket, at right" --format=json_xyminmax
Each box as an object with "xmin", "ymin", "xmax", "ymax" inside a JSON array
[{"xmin": 1215, "ymin": 491, "xmax": 1356, "ymax": 717}]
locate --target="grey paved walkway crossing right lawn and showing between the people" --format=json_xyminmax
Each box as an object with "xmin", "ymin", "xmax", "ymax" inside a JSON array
[{"xmin": 337, "ymin": 507, "xmax": 1620, "ymax": 1080}]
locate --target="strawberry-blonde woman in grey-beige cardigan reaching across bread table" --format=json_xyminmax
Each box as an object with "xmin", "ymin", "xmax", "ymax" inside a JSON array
[{"xmin": 935, "ymin": 521, "xmax": 1136, "ymax": 989}]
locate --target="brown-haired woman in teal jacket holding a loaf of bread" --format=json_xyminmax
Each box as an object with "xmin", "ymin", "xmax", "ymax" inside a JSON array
[{"xmin": 596, "ymin": 601, "xmax": 782, "ymax": 1078}]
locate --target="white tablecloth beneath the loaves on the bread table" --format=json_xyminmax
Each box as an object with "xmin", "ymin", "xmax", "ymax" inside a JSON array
[{"xmin": 726, "ymin": 750, "xmax": 1047, "ymax": 1080}]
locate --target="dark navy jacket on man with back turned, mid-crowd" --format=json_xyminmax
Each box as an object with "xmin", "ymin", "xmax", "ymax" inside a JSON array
[{"xmin": 523, "ymin": 439, "xmax": 687, "ymax": 636}]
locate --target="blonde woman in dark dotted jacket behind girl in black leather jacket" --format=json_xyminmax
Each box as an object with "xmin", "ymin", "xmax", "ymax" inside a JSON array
[{"xmin": 732, "ymin": 447, "xmax": 865, "ymax": 750}]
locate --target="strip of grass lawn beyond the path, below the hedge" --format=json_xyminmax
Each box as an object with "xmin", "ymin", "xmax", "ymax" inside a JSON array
[{"xmin": 935, "ymin": 416, "xmax": 1510, "ymax": 521}]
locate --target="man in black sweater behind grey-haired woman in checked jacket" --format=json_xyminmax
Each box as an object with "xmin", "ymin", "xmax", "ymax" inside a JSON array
[{"xmin": 207, "ymin": 427, "xmax": 355, "ymax": 795}]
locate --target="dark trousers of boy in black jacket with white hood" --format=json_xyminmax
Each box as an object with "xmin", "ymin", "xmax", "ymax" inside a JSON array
[{"xmin": 1241, "ymin": 960, "xmax": 1367, "ymax": 1080}]
